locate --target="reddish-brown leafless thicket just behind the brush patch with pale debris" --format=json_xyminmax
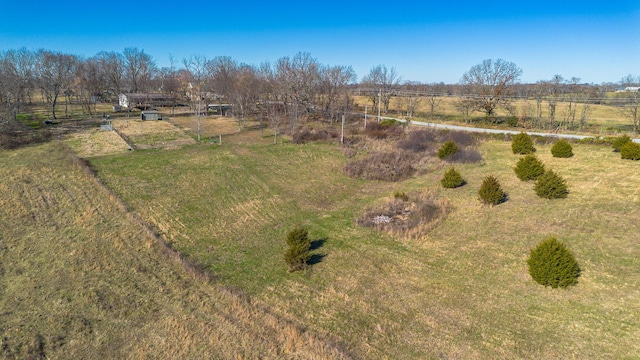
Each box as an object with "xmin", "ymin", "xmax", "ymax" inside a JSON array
[{"xmin": 344, "ymin": 152, "xmax": 415, "ymax": 181}]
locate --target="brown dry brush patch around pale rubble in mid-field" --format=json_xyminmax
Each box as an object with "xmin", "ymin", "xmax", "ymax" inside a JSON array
[{"xmin": 356, "ymin": 191, "xmax": 449, "ymax": 238}]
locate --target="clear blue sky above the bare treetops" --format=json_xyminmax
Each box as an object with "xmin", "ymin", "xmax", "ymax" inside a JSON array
[{"xmin": 0, "ymin": 0, "xmax": 640, "ymax": 83}]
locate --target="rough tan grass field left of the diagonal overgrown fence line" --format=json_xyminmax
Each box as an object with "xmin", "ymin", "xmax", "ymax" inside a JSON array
[{"xmin": 0, "ymin": 142, "xmax": 349, "ymax": 359}]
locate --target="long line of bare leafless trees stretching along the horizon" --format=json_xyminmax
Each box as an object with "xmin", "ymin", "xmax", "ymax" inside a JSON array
[{"xmin": 0, "ymin": 47, "xmax": 640, "ymax": 130}]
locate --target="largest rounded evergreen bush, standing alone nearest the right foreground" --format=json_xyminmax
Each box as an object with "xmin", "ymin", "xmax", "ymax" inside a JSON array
[{"xmin": 527, "ymin": 237, "xmax": 580, "ymax": 289}]
